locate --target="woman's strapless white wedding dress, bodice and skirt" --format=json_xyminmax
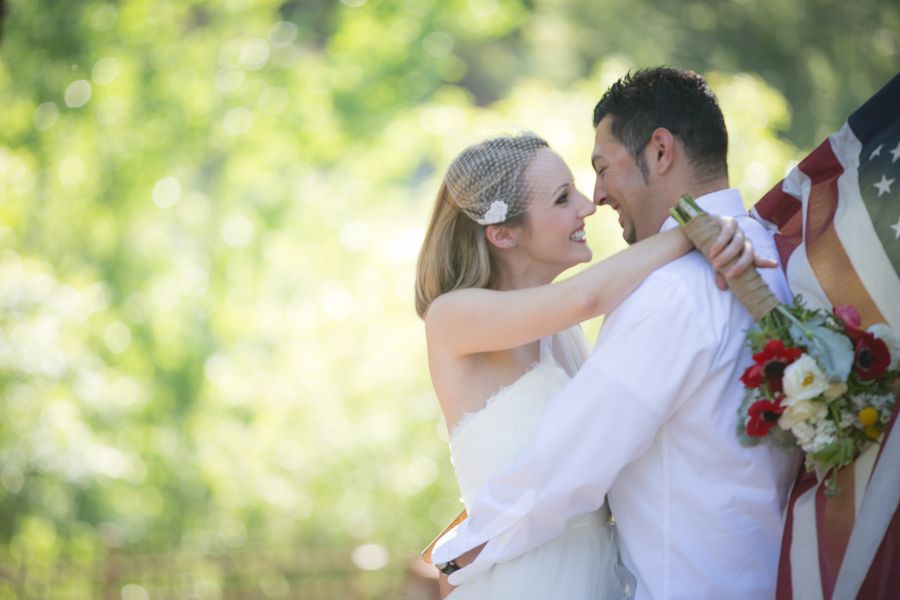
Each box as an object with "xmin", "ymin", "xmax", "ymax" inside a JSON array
[{"xmin": 447, "ymin": 327, "xmax": 634, "ymax": 600}]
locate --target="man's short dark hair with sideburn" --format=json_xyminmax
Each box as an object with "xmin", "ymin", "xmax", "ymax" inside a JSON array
[{"xmin": 594, "ymin": 67, "xmax": 728, "ymax": 180}]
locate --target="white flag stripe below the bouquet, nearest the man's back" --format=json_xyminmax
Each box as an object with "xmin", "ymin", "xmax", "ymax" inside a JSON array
[{"xmin": 791, "ymin": 487, "xmax": 823, "ymax": 600}]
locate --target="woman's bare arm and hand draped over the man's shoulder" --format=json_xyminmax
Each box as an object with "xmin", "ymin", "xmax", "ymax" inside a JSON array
[{"xmin": 425, "ymin": 219, "xmax": 753, "ymax": 355}]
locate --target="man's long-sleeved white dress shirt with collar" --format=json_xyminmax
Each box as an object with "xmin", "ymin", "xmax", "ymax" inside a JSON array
[{"xmin": 433, "ymin": 189, "xmax": 798, "ymax": 599}]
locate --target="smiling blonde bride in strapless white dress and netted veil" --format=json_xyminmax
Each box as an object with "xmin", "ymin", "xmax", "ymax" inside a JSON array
[{"xmin": 416, "ymin": 134, "xmax": 753, "ymax": 600}]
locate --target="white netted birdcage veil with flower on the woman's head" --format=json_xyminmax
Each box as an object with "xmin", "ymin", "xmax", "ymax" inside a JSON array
[{"xmin": 445, "ymin": 132, "xmax": 548, "ymax": 225}]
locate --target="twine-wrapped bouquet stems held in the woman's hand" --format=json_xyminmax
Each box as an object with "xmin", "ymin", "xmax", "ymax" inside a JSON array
[{"xmin": 671, "ymin": 195, "xmax": 779, "ymax": 323}]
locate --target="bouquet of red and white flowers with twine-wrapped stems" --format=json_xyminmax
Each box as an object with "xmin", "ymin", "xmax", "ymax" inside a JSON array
[{"xmin": 672, "ymin": 196, "xmax": 900, "ymax": 495}]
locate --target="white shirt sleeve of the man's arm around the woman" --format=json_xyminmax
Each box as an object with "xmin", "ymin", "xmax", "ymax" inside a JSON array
[{"xmin": 434, "ymin": 264, "xmax": 713, "ymax": 585}]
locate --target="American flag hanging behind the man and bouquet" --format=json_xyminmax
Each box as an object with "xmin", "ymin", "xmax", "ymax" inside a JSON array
[{"xmin": 751, "ymin": 75, "xmax": 900, "ymax": 600}]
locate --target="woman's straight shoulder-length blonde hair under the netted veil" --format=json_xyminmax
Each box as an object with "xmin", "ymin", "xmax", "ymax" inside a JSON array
[{"xmin": 416, "ymin": 134, "xmax": 548, "ymax": 319}]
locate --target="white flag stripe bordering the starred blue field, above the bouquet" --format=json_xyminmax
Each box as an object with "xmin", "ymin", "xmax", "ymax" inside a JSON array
[{"xmin": 828, "ymin": 123, "xmax": 900, "ymax": 329}]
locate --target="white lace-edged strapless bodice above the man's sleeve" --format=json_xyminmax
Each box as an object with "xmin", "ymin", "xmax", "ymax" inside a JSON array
[{"xmin": 450, "ymin": 327, "xmax": 587, "ymax": 508}]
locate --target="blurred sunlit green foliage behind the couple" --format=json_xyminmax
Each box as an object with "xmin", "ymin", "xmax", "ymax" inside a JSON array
[{"xmin": 0, "ymin": 0, "xmax": 900, "ymax": 598}]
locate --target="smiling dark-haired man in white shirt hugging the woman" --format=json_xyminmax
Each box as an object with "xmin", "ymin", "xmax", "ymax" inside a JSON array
[{"xmin": 433, "ymin": 68, "xmax": 798, "ymax": 599}]
